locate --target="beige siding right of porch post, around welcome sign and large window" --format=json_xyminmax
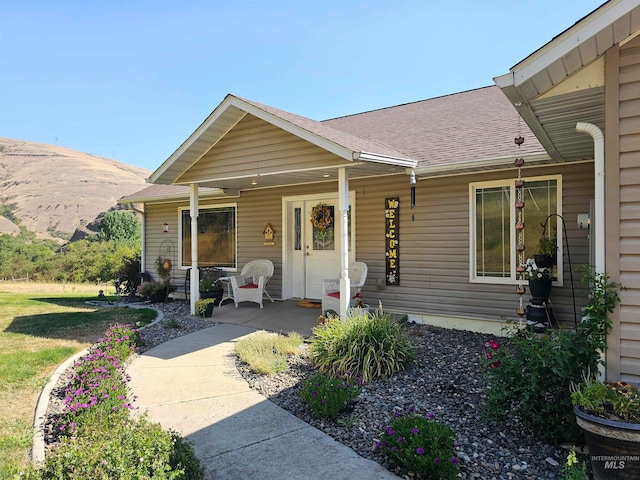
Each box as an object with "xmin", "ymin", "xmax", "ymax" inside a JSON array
[{"xmin": 351, "ymin": 163, "xmax": 594, "ymax": 325}]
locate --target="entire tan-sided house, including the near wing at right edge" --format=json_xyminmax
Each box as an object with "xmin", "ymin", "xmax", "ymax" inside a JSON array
[{"xmin": 121, "ymin": 0, "xmax": 640, "ymax": 382}]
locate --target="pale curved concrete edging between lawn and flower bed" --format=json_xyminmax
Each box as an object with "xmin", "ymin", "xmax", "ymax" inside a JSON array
[{"xmin": 31, "ymin": 302, "xmax": 164, "ymax": 464}]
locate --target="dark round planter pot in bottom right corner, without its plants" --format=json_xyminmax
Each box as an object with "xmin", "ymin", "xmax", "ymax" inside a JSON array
[{"xmin": 573, "ymin": 406, "xmax": 640, "ymax": 480}]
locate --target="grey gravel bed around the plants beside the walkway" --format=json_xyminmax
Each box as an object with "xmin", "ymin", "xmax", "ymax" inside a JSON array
[{"xmin": 43, "ymin": 302, "xmax": 567, "ymax": 480}]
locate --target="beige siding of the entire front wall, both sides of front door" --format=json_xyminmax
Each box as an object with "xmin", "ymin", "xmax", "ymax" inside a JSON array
[{"xmin": 146, "ymin": 163, "xmax": 593, "ymax": 324}]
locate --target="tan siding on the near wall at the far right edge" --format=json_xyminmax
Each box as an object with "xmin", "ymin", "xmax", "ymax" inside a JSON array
[{"xmin": 607, "ymin": 38, "xmax": 640, "ymax": 382}]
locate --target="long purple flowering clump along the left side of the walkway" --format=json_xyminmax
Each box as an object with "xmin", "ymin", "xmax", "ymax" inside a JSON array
[{"xmin": 57, "ymin": 324, "xmax": 140, "ymax": 436}]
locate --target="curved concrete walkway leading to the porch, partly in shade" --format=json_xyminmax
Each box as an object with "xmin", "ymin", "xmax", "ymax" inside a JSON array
[{"xmin": 127, "ymin": 320, "xmax": 398, "ymax": 480}]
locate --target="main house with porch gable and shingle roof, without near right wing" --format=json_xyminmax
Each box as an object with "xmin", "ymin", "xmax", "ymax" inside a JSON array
[{"xmin": 121, "ymin": 86, "xmax": 594, "ymax": 334}]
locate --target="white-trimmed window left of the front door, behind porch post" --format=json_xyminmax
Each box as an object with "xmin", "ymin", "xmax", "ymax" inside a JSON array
[{"xmin": 178, "ymin": 204, "xmax": 238, "ymax": 270}]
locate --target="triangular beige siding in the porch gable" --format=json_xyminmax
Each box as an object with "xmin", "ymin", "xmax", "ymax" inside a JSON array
[{"xmin": 178, "ymin": 115, "xmax": 349, "ymax": 183}]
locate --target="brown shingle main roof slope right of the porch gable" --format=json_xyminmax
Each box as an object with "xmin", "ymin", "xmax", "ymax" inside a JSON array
[{"xmin": 322, "ymin": 86, "xmax": 544, "ymax": 167}]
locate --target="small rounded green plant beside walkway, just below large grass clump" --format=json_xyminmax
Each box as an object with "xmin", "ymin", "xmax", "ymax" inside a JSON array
[{"xmin": 300, "ymin": 372, "xmax": 362, "ymax": 418}]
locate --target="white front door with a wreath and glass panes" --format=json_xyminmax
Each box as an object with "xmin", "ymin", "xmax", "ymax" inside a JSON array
[{"xmin": 283, "ymin": 193, "xmax": 355, "ymax": 300}]
